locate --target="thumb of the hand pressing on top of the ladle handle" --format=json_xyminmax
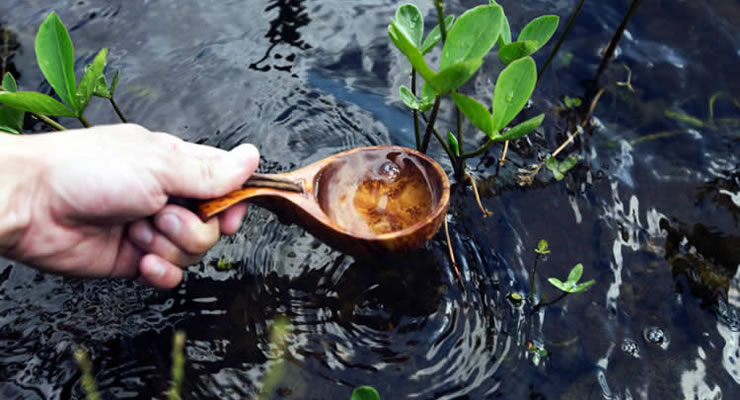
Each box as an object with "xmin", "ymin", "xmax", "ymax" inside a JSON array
[{"xmin": 162, "ymin": 143, "xmax": 260, "ymax": 199}]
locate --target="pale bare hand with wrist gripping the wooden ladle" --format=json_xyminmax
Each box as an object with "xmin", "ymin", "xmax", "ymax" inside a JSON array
[{"xmin": 0, "ymin": 124, "xmax": 259, "ymax": 289}]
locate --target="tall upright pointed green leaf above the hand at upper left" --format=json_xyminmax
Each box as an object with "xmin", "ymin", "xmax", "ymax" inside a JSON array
[{"xmin": 35, "ymin": 12, "xmax": 78, "ymax": 112}]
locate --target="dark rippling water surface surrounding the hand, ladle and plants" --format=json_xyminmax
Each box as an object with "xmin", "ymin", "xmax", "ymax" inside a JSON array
[{"xmin": 0, "ymin": 0, "xmax": 740, "ymax": 399}]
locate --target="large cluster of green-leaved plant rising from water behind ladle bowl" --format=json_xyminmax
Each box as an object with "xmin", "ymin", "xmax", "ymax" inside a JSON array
[{"xmin": 388, "ymin": 0, "xmax": 559, "ymax": 179}]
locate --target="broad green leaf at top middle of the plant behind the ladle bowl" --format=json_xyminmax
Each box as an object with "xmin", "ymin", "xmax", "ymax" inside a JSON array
[{"xmin": 439, "ymin": 5, "xmax": 504, "ymax": 70}]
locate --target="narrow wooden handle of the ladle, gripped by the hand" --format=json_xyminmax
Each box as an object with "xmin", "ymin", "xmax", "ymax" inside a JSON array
[{"xmin": 194, "ymin": 174, "xmax": 304, "ymax": 221}]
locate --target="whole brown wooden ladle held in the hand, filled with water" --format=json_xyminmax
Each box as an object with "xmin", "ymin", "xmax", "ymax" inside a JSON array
[{"xmin": 198, "ymin": 146, "xmax": 450, "ymax": 255}]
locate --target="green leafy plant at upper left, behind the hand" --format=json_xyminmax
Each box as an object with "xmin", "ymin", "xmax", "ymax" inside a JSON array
[{"xmin": 0, "ymin": 12, "xmax": 126, "ymax": 134}]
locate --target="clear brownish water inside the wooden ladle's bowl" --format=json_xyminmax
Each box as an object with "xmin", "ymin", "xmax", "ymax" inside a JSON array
[{"xmin": 316, "ymin": 150, "xmax": 433, "ymax": 235}]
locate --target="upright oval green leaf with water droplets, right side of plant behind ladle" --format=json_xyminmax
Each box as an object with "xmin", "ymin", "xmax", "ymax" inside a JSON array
[{"xmin": 493, "ymin": 57, "xmax": 537, "ymax": 131}]
